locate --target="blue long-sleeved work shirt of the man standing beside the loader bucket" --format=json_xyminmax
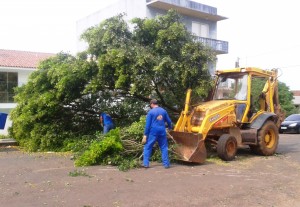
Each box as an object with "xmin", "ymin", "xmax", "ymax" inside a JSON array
[{"xmin": 144, "ymin": 107, "xmax": 172, "ymax": 137}]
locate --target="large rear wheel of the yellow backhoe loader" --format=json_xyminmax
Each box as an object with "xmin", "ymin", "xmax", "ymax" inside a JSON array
[{"xmin": 251, "ymin": 121, "xmax": 279, "ymax": 156}]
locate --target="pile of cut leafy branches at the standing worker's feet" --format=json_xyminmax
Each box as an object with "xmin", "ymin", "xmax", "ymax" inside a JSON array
[{"xmin": 75, "ymin": 116, "xmax": 178, "ymax": 171}]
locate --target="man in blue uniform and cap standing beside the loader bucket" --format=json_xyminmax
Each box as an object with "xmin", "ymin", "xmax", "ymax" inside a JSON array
[{"xmin": 143, "ymin": 99, "xmax": 172, "ymax": 168}]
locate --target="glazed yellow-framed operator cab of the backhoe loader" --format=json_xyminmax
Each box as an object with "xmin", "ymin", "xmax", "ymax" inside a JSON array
[{"xmin": 212, "ymin": 69, "xmax": 272, "ymax": 123}]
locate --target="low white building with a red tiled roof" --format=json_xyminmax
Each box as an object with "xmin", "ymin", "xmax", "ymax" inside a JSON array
[{"xmin": 0, "ymin": 49, "xmax": 54, "ymax": 134}]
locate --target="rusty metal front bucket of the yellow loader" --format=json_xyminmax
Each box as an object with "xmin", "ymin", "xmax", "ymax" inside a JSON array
[{"xmin": 169, "ymin": 131, "xmax": 207, "ymax": 163}]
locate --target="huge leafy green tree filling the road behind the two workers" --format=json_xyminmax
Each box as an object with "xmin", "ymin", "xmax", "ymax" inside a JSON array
[{"xmin": 10, "ymin": 10, "xmax": 215, "ymax": 156}]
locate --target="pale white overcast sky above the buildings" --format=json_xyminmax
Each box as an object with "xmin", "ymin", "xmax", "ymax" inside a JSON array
[{"xmin": 0, "ymin": 0, "xmax": 300, "ymax": 90}]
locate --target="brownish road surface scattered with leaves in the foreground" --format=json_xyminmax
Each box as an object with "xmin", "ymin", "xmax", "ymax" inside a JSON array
[{"xmin": 0, "ymin": 135, "xmax": 300, "ymax": 207}]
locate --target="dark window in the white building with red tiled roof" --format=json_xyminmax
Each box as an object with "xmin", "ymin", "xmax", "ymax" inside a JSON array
[{"xmin": 0, "ymin": 72, "xmax": 18, "ymax": 103}]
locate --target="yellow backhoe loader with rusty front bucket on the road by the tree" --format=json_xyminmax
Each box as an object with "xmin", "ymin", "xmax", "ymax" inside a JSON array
[{"xmin": 170, "ymin": 67, "xmax": 284, "ymax": 163}]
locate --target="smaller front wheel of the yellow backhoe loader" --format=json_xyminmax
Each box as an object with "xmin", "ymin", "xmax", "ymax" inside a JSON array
[{"xmin": 217, "ymin": 134, "xmax": 237, "ymax": 161}]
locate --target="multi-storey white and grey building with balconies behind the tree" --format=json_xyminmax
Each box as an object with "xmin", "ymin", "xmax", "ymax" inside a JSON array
[{"xmin": 77, "ymin": 0, "xmax": 228, "ymax": 72}]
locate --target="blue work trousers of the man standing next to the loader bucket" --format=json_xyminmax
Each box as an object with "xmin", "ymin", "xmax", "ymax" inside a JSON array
[{"xmin": 143, "ymin": 134, "xmax": 170, "ymax": 167}]
